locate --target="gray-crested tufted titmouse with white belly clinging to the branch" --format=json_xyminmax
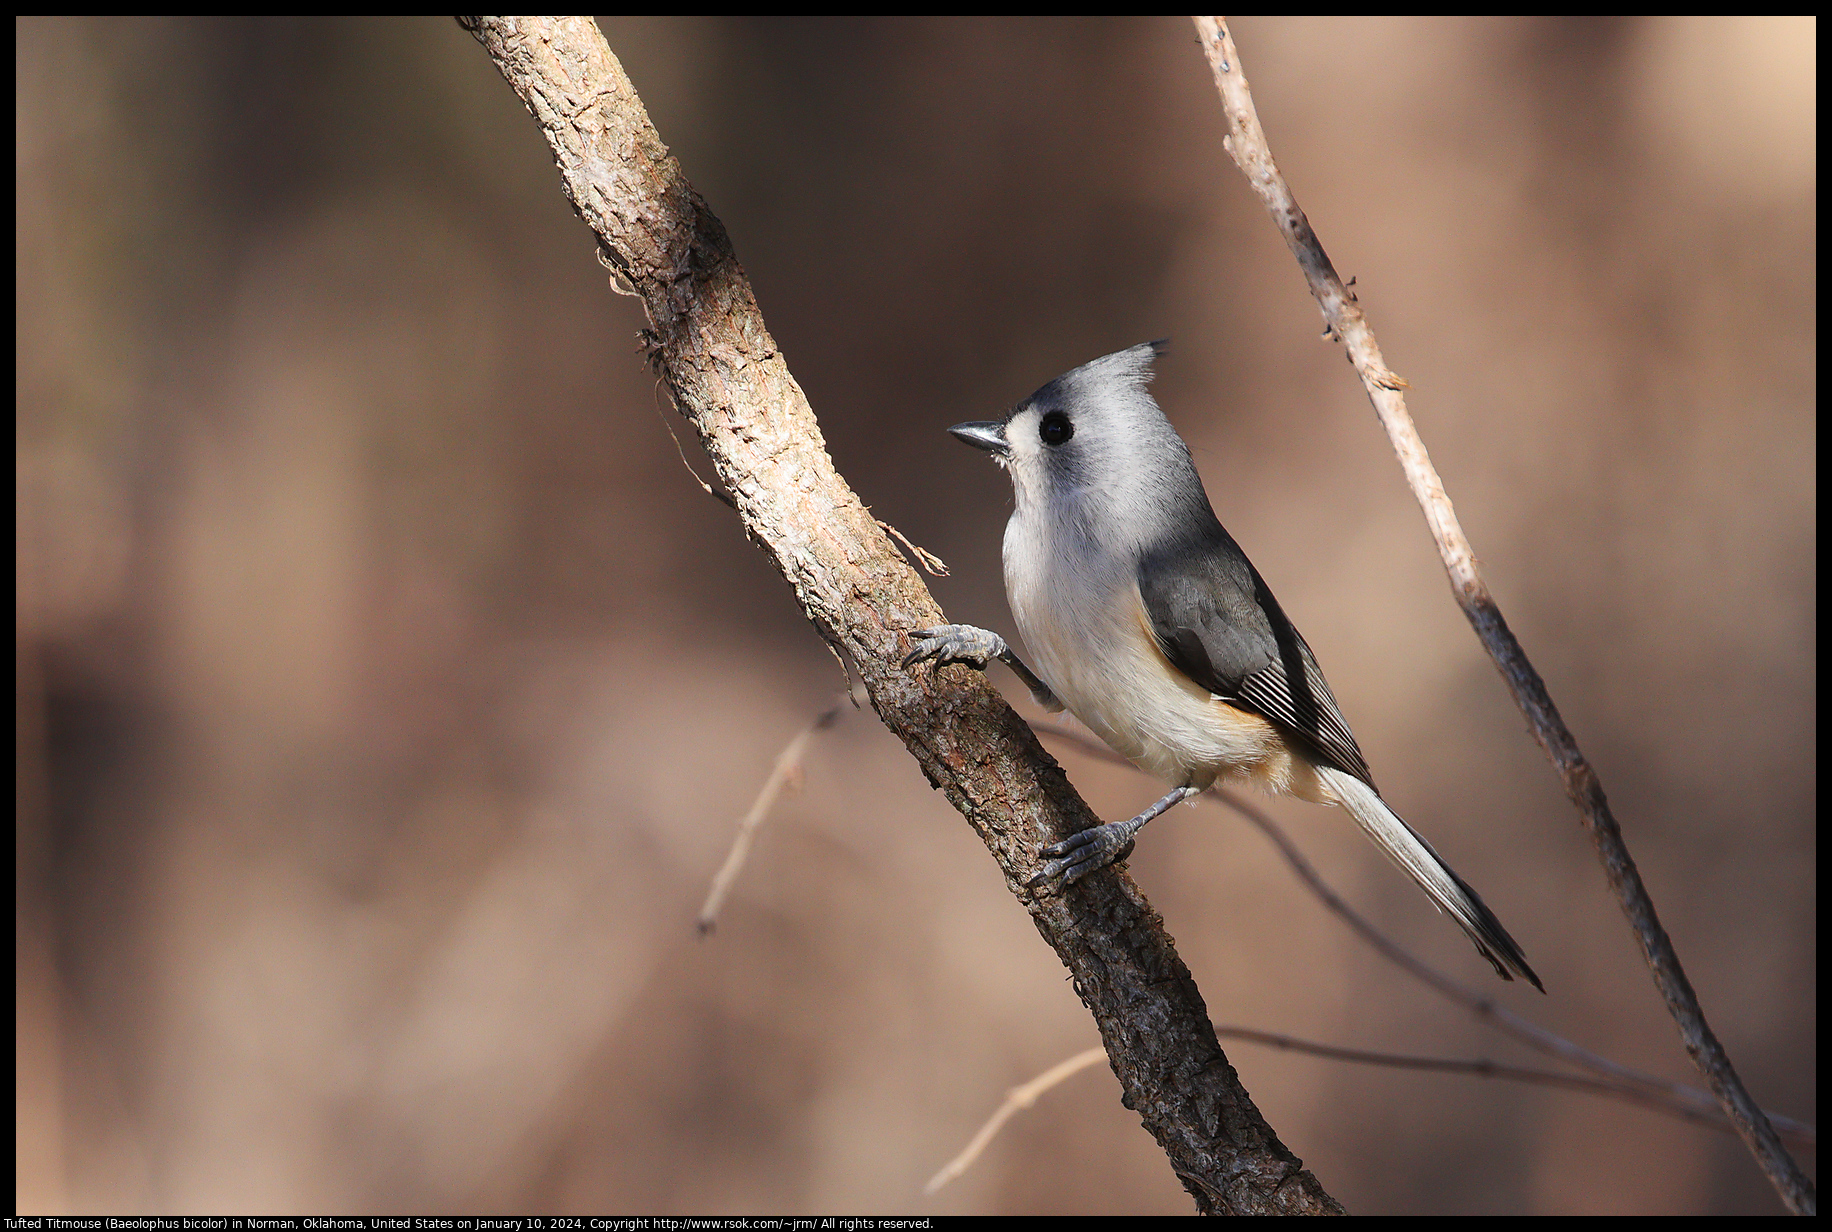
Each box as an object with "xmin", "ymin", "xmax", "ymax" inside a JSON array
[{"xmin": 903, "ymin": 343, "xmax": 1544, "ymax": 992}]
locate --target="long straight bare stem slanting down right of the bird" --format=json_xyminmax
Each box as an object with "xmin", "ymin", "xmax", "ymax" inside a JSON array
[{"xmin": 1193, "ymin": 17, "xmax": 1817, "ymax": 1216}]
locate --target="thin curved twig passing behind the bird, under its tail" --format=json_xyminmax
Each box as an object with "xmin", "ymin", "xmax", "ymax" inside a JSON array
[{"xmin": 1031, "ymin": 721, "xmax": 1819, "ymax": 1146}]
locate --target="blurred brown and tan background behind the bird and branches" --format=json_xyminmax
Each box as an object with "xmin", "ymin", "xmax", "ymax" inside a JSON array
[{"xmin": 15, "ymin": 18, "xmax": 1817, "ymax": 1214}]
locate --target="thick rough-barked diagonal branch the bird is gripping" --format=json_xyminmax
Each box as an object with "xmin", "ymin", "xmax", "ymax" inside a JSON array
[{"xmin": 460, "ymin": 17, "xmax": 1341, "ymax": 1214}]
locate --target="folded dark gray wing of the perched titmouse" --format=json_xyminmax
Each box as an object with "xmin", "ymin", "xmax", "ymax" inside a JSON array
[{"xmin": 1140, "ymin": 523, "xmax": 1378, "ymax": 790}]
